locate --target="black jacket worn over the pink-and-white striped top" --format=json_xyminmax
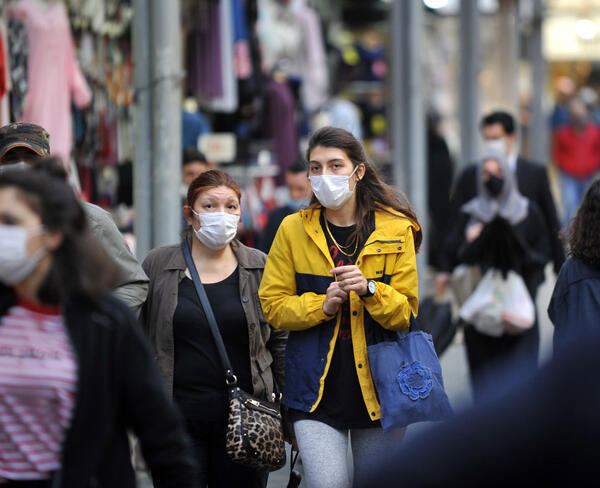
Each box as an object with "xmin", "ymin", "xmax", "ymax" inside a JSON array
[{"xmin": 0, "ymin": 287, "xmax": 196, "ymax": 488}]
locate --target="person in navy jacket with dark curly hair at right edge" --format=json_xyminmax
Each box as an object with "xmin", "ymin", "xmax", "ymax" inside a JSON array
[{"xmin": 548, "ymin": 180, "xmax": 600, "ymax": 350}]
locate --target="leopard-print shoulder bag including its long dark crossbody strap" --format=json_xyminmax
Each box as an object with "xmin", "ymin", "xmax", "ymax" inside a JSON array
[{"xmin": 181, "ymin": 241, "xmax": 286, "ymax": 471}]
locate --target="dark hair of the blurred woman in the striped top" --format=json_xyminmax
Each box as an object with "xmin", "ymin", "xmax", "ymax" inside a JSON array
[{"xmin": 0, "ymin": 169, "xmax": 117, "ymax": 303}]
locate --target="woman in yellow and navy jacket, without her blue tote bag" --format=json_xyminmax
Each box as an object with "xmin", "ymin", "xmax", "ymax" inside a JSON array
[{"xmin": 259, "ymin": 127, "xmax": 421, "ymax": 488}]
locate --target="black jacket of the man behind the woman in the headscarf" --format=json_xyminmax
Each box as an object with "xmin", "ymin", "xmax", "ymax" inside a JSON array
[{"xmin": 444, "ymin": 157, "xmax": 565, "ymax": 274}]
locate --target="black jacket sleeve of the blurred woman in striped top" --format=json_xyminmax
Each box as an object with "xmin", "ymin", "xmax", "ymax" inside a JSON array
[{"xmin": 118, "ymin": 304, "xmax": 196, "ymax": 488}]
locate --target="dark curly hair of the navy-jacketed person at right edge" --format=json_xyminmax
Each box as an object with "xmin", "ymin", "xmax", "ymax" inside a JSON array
[{"xmin": 566, "ymin": 180, "xmax": 600, "ymax": 268}]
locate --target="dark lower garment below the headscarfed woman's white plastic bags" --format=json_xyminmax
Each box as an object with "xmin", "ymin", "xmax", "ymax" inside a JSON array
[{"xmin": 465, "ymin": 319, "xmax": 540, "ymax": 401}]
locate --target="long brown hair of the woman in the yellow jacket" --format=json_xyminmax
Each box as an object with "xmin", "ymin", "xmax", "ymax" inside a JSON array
[{"xmin": 306, "ymin": 126, "xmax": 423, "ymax": 252}]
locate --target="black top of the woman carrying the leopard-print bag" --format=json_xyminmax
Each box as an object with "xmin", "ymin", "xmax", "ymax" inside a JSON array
[{"xmin": 173, "ymin": 268, "xmax": 253, "ymax": 421}]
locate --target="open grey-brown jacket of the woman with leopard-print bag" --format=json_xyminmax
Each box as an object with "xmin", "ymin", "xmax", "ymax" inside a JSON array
[{"xmin": 142, "ymin": 240, "xmax": 288, "ymax": 400}]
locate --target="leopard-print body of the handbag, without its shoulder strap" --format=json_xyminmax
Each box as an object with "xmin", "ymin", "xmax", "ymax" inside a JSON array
[{"xmin": 225, "ymin": 386, "xmax": 286, "ymax": 471}]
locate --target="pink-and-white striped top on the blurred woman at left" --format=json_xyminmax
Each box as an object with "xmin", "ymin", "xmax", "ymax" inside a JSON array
[{"xmin": 0, "ymin": 301, "xmax": 77, "ymax": 484}]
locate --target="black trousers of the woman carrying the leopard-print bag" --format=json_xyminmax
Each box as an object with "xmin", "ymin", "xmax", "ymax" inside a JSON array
[{"xmin": 186, "ymin": 419, "xmax": 269, "ymax": 488}]
